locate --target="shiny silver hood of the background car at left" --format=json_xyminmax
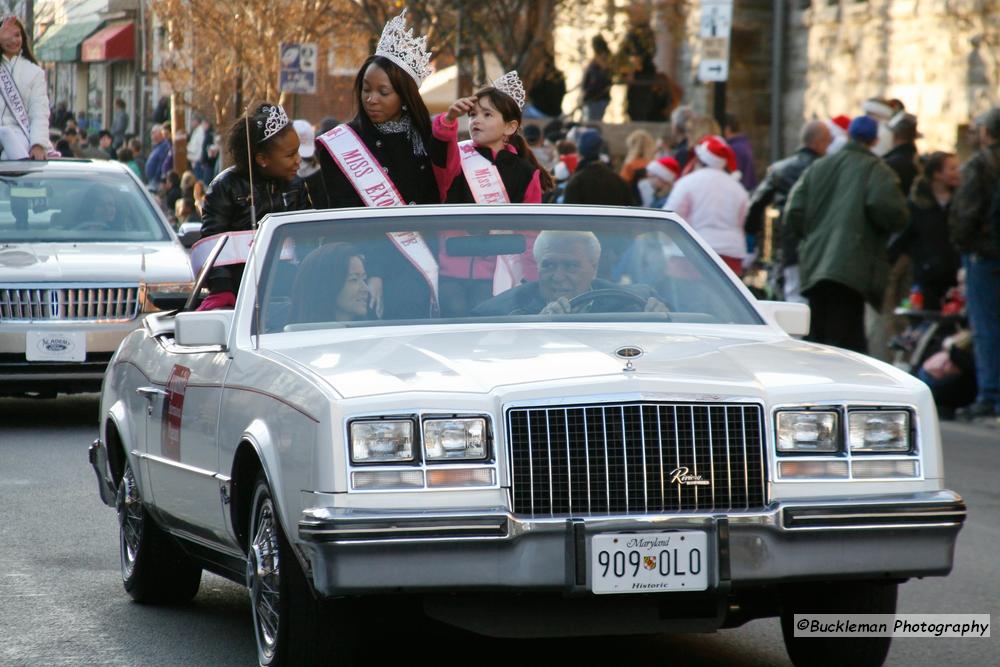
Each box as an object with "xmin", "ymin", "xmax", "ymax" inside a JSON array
[{"xmin": 0, "ymin": 242, "xmax": 193, "ymax": 283}]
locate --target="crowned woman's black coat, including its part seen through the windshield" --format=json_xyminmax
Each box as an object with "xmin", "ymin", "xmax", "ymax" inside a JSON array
[{"xmin": 316, "ymin": 119, "xmax": 441, "ymax": 319}]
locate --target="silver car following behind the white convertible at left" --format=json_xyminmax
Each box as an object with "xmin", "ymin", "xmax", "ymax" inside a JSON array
[{"xmin": 0, "ymin": 160, "xmax": 193, "ymax": 397}]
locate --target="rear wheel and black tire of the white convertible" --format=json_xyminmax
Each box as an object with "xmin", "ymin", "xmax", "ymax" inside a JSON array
[{"xmin": 115, "ymin": 457, "xmax": 201, "ymax": 604}]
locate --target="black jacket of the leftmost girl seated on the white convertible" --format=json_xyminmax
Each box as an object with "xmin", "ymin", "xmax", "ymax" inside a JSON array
[{"xmin": 201, "ymin": 167, "xmax": 313, "ymax": 238}]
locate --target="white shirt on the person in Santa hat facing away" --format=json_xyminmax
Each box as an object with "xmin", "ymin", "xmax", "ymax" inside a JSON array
[{"xmin": 663, "ymin": 167, "xmax": 750, "ymax": 259}]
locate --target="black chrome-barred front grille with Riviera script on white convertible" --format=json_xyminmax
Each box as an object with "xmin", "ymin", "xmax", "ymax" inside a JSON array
[{"xmin": 507, "ymin": 403, "xmax": 766, "ymax": 517}]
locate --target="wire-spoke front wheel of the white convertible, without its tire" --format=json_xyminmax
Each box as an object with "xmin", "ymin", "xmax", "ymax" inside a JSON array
[{"xmin": 247, "ymin": 496, "xmax": 281, "ymax": 659}]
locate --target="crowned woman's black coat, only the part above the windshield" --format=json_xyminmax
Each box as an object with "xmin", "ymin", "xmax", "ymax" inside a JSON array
[{"xmin": 316, "ymin": 118, "xmax": 441, "ymax": 208}]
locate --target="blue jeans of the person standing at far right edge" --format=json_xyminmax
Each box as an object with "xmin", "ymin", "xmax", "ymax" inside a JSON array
[{"xmin": 962, "ymin": 255, "xmax": 1000, "ymax": 410}]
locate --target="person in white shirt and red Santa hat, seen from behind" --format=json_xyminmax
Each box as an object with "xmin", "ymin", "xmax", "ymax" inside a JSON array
[{"xmin": 663, "ymin": 135, "xmax": 750, "ymax": 275}]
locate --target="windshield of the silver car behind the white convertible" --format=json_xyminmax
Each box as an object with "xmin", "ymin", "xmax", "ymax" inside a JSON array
[{"xmin": 0, "ymin": 171, "xmax": 170, "ymax": 243}]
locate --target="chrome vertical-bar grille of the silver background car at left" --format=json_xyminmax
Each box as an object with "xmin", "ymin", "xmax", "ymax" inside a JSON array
[{"xmin": 0, "ymin": 285, "xmax": 139, "ymax": 322}]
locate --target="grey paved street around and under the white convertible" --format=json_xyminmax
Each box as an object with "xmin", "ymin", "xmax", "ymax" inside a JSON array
[{"xmin": 0, "ymin": 396, "xmax": 1000, "ymax": 666}]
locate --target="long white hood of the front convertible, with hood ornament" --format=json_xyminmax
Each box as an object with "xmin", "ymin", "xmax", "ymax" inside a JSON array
[{"xmin": 276, "ymin": 325, "xmax": 907, "ymax": 398}]
